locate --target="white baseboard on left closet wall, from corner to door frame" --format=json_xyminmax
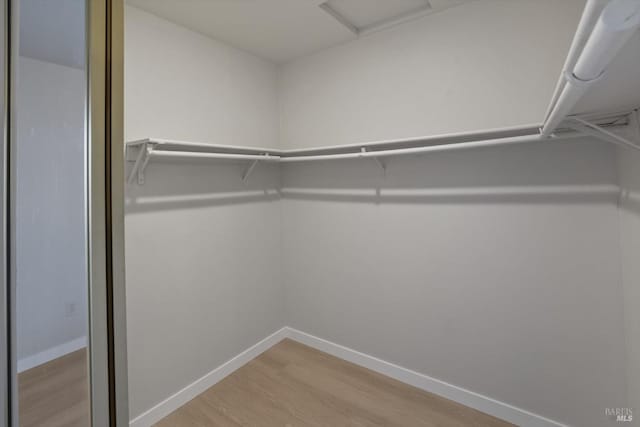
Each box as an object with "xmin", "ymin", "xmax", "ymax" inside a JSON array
[{"xmin": 130, "ymin": 328, "xmax": 287, "ymax": 427}]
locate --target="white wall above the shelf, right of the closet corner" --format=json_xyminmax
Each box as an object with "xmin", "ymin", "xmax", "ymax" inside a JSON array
[{"xmin": 280, "ymin": 0, "xmax": 584, "ymax": 148}]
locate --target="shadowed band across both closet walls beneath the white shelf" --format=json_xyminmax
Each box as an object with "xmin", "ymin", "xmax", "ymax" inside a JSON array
[{"xmin": 126, "ymin": 139, "xmax": 620, "ymax": 213}]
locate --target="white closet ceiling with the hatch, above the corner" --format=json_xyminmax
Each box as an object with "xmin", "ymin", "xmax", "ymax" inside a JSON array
[{"xmin": 128, "ymin": 0, "xmax": 472, "ymax": 63}]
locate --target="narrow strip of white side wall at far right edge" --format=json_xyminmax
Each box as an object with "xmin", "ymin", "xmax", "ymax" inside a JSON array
[{"xmin": 618, "ymin": 140, "xmax": 640, "ymax": 426}]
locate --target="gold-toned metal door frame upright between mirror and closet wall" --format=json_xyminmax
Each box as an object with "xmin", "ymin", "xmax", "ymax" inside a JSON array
[{"xmin": 86, "ymin": 0, "xmax": 129, "ymax": 427}]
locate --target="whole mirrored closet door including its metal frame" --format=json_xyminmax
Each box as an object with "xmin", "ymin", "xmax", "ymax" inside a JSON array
[{"xmin": 0, "ymin": 0, "xmax": 127, "ymax": 427}]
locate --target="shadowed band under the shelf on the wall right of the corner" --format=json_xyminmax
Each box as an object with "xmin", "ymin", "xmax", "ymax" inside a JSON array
[{"xmin": 281, "ymin": 139, "xmax": 620, "ymax": 204}]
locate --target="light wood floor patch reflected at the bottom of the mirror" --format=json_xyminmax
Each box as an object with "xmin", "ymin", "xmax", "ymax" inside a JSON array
[{"xmin": 18, "ymin": 349, "xmax": 90, "ymax": 427}]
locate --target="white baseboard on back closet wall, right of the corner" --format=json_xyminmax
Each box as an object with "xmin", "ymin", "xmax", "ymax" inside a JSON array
[{"xmin": 287, "ymin": 328, "xmax": 567, "ymax": 427}]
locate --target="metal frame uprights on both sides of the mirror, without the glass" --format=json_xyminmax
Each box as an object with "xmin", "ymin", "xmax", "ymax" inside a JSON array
[{"xmin": 0, "ymin": 0, "xmax": 129, "ymax": 427}]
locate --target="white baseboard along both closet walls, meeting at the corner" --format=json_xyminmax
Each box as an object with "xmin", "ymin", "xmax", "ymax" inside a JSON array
[{"xmin": 130, "ymin": 327, "xmax": 567, "ymax": 427}]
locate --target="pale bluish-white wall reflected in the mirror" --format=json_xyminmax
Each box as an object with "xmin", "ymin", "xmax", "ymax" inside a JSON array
[{"xmin": 16, "ymin": 57, "xmax": 88, "ymax": 364}]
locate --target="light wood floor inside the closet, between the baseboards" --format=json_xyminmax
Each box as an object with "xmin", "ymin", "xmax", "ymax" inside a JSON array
[{"xmin": 156, "ymin": 340, "xmax": 512, "ymax": 427}]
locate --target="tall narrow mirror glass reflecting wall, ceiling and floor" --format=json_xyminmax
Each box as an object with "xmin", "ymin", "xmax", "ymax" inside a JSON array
[{"xmin": 12, "ymin": 0, "xmax": 90, "ymax": 427}]
